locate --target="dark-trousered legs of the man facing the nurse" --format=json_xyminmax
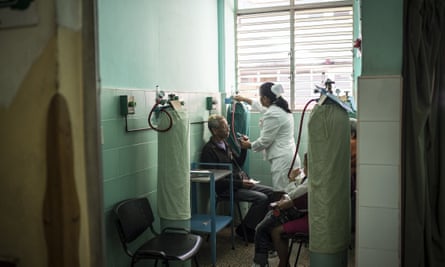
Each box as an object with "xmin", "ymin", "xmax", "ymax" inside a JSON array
[{"xmin": 235, "ymin": 185, "xmax": 273, "ymax": 230}]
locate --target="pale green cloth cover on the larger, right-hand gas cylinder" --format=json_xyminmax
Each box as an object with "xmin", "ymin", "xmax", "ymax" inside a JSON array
[{"xmin": 308, "ymin": 102, "xmax": 351, "ymax": 253}]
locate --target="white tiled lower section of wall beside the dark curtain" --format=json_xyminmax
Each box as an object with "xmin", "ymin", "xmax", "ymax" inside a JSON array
[{"xmin": 356, "ymin": 76, "xmax": 402, "ymax": 267}]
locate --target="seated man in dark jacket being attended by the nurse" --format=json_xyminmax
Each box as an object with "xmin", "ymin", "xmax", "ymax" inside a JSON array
[{"xmin": 201, "ymin": 115, "xmax": 274, "ymax": 242}]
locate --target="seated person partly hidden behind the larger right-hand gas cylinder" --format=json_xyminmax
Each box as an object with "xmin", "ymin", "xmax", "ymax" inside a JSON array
[{"xmin": 253, "ymin": 154, "xmax": 309, "ymax": 267}]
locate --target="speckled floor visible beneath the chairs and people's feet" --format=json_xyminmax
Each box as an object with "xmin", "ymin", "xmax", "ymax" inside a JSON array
[{"xmin": 198, "ymin": 228, "xmax": 355, "ymax": 267}]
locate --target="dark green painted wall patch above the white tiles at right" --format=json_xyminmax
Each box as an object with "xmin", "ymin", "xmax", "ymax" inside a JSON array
[{"xmin": 361, "ymin": 0, "xmax": 403, "ymax": 76}]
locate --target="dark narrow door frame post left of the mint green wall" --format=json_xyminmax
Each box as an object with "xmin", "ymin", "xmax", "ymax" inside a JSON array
[{"xmin": 82, "ymin": 0, "xmax": 105, "ymax": 266}]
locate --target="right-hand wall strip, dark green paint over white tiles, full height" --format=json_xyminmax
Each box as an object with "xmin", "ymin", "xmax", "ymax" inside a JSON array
[{"xmin": 355, "ymin": 0, "xmax": 406, "ymax": 266}]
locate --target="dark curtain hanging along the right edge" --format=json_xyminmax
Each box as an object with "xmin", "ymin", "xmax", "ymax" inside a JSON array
[{"xmin": 402, "ymin": 0, "xmax": 445, "ymax": 266}]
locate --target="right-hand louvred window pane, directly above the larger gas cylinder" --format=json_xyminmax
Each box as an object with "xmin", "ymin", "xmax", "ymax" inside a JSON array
[{"xmin": 294, "ymin": 7, "xmax": 352, "ymax": 109}]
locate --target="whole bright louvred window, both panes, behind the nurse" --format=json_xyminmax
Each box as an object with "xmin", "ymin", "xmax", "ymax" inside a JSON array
[{"xmin": 236, "ymin": 0, "xmax": 353, "ymax": 109}]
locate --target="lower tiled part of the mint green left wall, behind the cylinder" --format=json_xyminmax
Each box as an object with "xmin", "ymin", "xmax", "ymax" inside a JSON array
[{"xmin": 101, "ymin": 88, "xmax": 219, "ymax": 267}]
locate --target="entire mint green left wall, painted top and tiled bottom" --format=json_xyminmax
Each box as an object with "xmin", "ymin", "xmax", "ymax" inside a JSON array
[{"xmin": 97, "ymin": 0, "xmax": 229, "ymax": 267}]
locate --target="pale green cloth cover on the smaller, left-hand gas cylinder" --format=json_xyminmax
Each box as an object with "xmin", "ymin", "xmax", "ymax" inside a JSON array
[{"xmin": 158, "ymin": 109, "xmax": 191, "ymax": 220}]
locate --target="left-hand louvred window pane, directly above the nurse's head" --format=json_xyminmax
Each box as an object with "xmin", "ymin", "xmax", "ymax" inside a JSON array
[{"xmin": 237, "ymin": 12, "xmax": 290, "ymax": 100}]
